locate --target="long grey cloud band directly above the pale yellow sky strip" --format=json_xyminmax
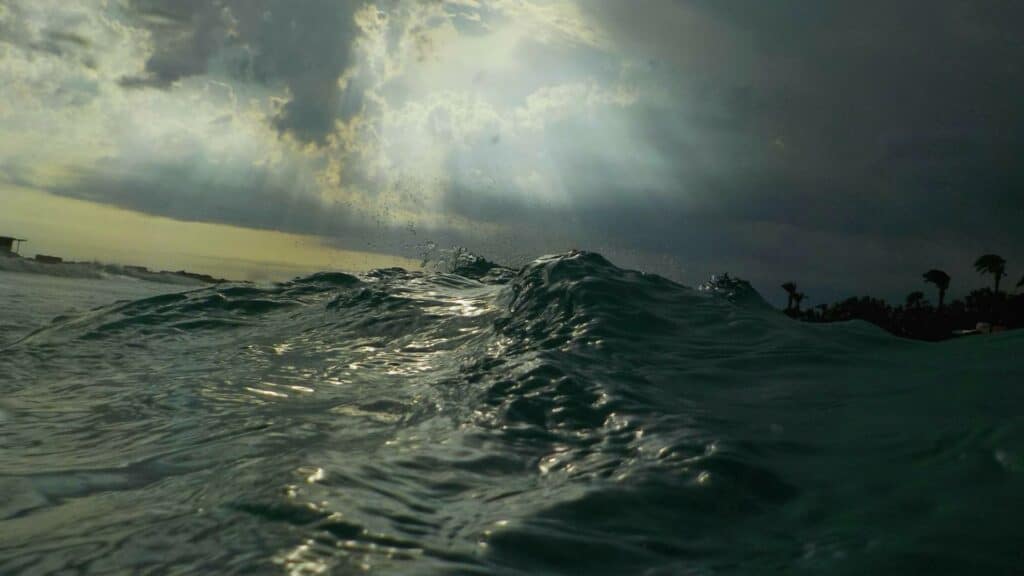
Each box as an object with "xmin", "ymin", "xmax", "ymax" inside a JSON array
[{"xmin": 37, "ymin": 138, "xmax": 505, "ymax": 258}]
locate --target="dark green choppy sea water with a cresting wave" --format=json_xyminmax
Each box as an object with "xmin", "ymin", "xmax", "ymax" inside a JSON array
[{"xmin": 0, "ymin": 252, "xmax": 1024, "ymax": 575}]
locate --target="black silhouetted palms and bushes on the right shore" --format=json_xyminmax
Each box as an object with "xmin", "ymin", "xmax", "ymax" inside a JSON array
[{"xmin": 782, "ymin": 254, "xmax": 1024, "ymax": 341}]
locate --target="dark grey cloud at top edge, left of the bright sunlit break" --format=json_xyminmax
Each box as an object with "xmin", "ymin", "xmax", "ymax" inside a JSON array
[{"xmin": 122, "ymin": 0, "xmax": 365, "ymax": 145}]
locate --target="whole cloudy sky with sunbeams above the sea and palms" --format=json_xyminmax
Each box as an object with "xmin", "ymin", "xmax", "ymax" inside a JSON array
[{"xmin": 0, "ymin": 0, "xmax": 1024, "ymax": 303}]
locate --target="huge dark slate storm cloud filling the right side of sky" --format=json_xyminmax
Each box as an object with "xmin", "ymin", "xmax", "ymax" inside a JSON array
[{"xmin": 557, "ymin": 0, "xmax": 1024, "ymax": 301}]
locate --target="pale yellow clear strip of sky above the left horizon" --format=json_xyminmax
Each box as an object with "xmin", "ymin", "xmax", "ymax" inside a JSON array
[{"xmin": 0, "ymin": 183, "xmax": 419, "ymax": 281}]
